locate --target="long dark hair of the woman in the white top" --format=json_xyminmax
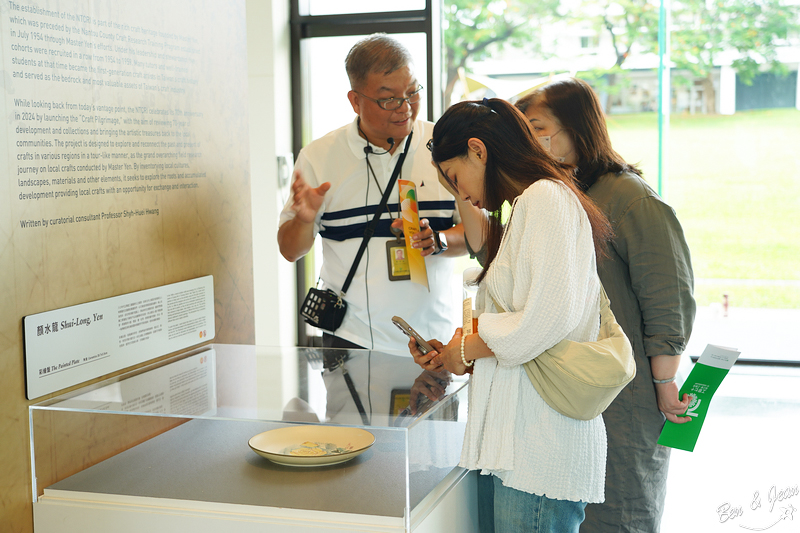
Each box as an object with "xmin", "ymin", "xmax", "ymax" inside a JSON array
[{"xmin": 429, "ymin": 98, "xmax": 611, "ymax": 281}]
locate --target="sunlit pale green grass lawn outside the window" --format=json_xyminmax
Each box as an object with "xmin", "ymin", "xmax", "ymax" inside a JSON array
[{"xmin": 608, "ymin": 109, "xmax": 800, "ymax": 308}]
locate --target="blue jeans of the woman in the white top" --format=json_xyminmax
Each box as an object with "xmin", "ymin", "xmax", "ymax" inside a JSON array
[{"xmin": 478, "ymin": 474, "xmax": 586, "ymax": 533}]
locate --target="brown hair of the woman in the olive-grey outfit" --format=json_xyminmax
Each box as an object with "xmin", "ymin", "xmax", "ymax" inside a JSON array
[{"xmin": 516, "ymin": 78, "xmax": 642, "ymax": 191}]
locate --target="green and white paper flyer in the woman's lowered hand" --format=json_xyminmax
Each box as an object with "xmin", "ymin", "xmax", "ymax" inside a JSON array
[{"xmin": 658, "ymin": 344, "xmax": 739, "ymax": 452}]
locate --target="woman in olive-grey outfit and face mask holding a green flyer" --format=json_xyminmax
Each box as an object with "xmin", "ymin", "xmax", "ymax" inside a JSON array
[{"xmin": 516, "ymin": 78, "xmax": 695, "ymax": 533}]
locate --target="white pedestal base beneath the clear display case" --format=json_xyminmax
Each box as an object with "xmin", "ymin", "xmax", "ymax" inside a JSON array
[{"xmin": 33, "ymin": 470, "xmax": 478, "ymax": 533}]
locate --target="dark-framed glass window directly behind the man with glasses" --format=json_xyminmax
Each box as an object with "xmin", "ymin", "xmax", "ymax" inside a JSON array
[{"xmin": 290, "ymin": 0, "xmax": 439, "ymax": 346}]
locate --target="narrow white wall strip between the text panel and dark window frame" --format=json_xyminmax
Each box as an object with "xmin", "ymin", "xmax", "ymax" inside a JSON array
[{"xmin": 246, "ymin": 0, "xmax": 297, "ymax": 346}]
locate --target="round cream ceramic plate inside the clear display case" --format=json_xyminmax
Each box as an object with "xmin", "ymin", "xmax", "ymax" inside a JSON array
[{"xmin": 248, "ymin": 426, "xmax": 375, "ymax": 466}]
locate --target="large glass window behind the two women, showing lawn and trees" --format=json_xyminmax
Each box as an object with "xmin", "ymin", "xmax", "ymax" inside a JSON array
[{"xmin": 444, "ymin": 0, "xmax": 800, "ymax": 360}]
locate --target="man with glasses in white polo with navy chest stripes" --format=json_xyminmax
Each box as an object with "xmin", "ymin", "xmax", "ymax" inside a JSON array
[{"xmin": 278, "ymin": 34, "xmax": 471, "ymax": 354}]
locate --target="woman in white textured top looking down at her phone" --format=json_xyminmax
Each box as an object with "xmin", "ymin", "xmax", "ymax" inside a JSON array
[{"xmin": 409, "ymin": 99, "xmax": 610, "ymax": 533}]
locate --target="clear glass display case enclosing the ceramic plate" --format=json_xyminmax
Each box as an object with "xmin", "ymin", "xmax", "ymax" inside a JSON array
[{"xmin": 30, "ymin": 344, "xmax": 475, "ymax": 532}]
